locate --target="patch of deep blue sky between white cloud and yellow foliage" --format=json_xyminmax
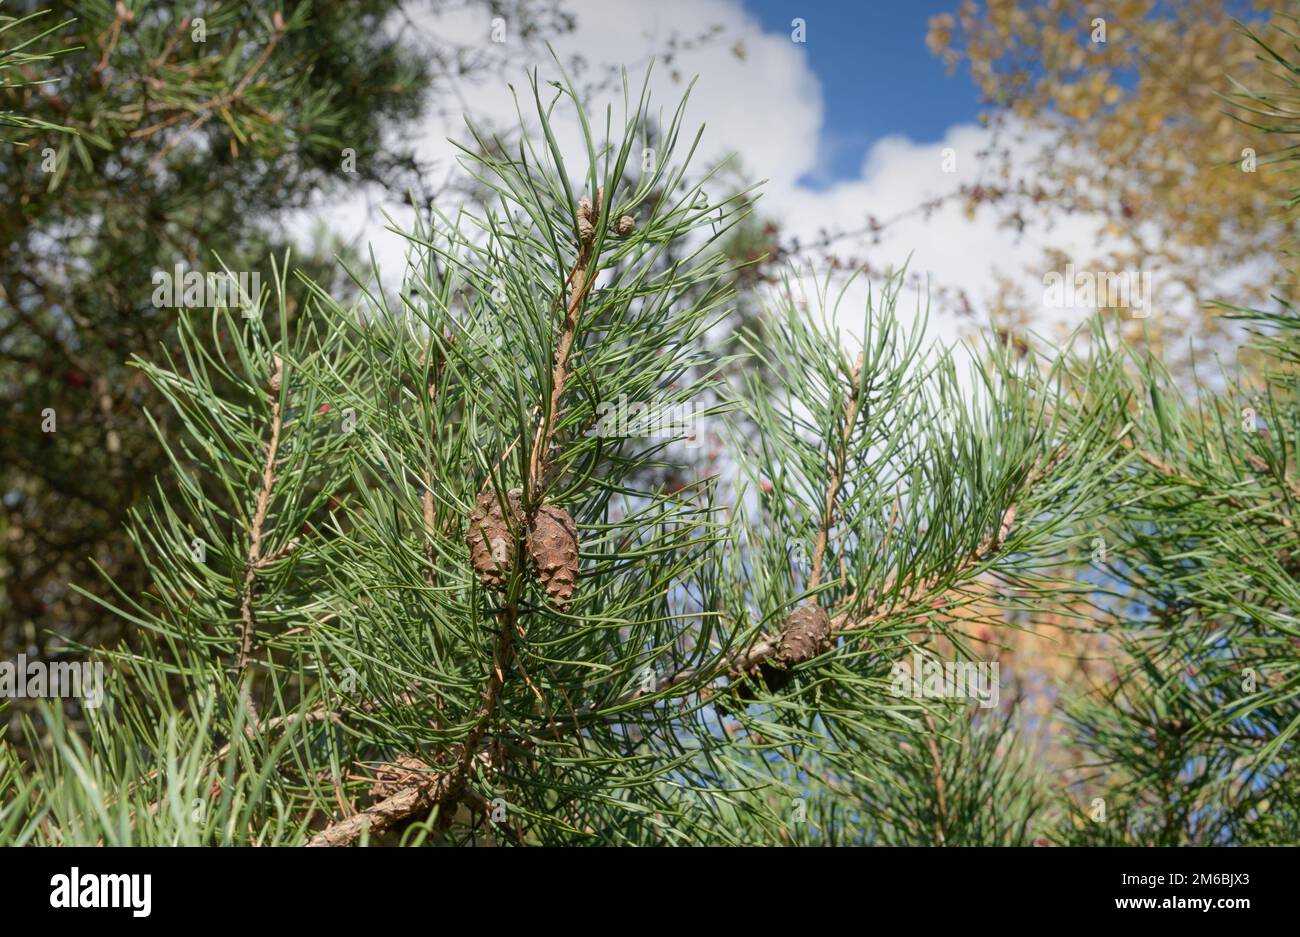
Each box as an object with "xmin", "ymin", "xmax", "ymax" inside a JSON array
[{"xmin": 744, "ymin": 0, "xmax": 980, "ymax": 188}]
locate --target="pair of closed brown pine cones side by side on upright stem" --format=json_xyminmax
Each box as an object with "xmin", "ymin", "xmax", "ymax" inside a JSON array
[{"xmin": 465, "ymin": 489, "xmax": 579, "ymax": 612}]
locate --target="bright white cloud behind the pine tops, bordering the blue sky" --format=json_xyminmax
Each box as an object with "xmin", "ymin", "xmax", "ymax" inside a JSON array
[{"xmin": 292, "ymin": 0, "xmax": 1118, "ymax": 353}]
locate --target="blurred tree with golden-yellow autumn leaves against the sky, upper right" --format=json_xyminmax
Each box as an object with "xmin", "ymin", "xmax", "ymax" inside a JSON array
[{"xmin": 928, "ymin": 0, "xmax": 1294, "ymax": 372}]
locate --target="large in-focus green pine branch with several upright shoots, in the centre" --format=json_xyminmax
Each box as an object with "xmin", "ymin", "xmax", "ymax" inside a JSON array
[{"xmin": 10, "ymin": 62, "xmax": 1138, "ymax": 846}]
